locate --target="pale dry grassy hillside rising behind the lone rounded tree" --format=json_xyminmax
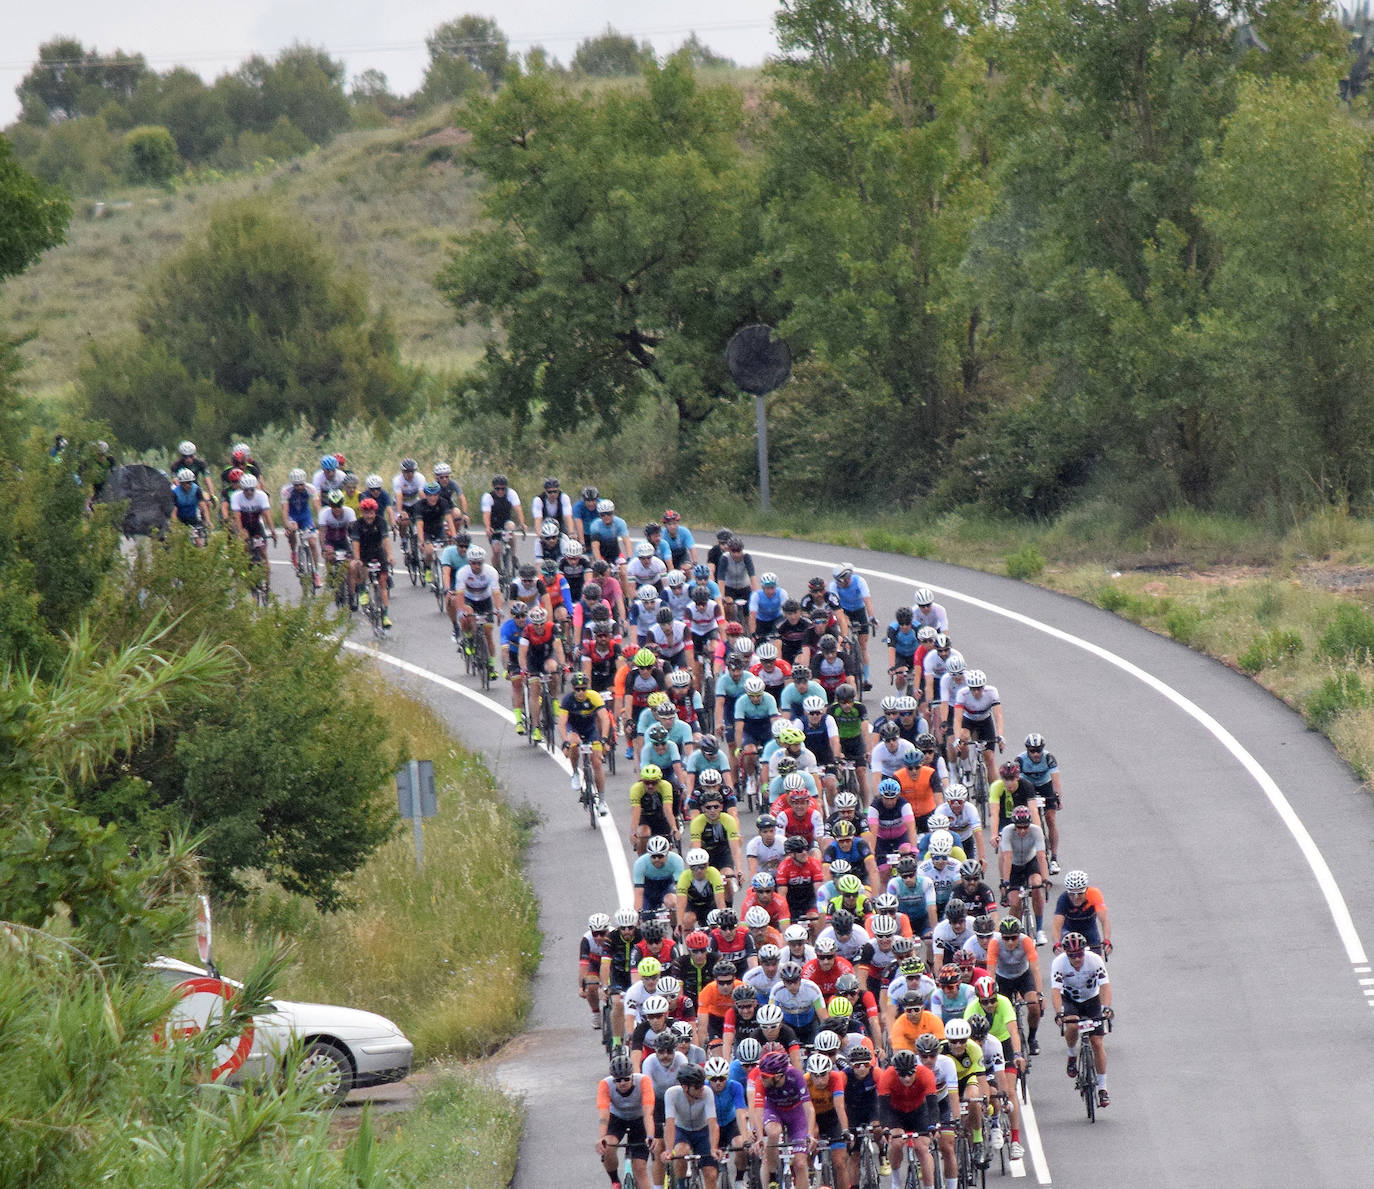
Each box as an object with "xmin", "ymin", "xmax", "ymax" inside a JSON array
[{"xmin": 0, "ymin": 113, "xmax": 494, "ymax": 405}]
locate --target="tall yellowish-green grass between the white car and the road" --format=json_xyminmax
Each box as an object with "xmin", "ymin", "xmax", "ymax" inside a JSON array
[{"xmin": 216, "ymin": 676, "xmax": 541, "ymax": 1061}]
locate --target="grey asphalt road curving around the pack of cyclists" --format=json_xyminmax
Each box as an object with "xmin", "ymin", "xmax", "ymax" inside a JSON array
[{"xmin": 273, "ymin": 539, "xmax": 1374, "ymax": 1189}]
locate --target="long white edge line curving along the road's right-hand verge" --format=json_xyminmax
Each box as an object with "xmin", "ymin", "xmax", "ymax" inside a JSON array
[{"xmin": 753, "ymin": 550, "xmax": 1369, "ymax": 964}]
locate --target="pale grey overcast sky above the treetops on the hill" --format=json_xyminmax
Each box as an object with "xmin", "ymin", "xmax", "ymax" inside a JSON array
[{"xmin": 0, "ymin": 0, "xmax": 776, "ymax": 126}]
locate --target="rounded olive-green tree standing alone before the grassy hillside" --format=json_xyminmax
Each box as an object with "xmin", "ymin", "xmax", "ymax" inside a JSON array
[{"xmin": 82, "ymin": 201, "xmax": 414, "ymax": 448}]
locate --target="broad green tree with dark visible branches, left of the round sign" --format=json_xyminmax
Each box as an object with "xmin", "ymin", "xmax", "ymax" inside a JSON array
[{"xmin": 438, "ymin": 55, "xmax": 767, "ymax": 429}]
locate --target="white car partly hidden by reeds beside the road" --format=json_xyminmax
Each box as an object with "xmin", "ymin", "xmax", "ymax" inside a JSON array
[{"xmin": 148, "ymin": 958, "xmax": 414, "ymax": 1102}]
